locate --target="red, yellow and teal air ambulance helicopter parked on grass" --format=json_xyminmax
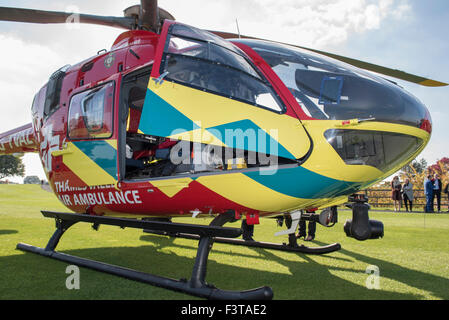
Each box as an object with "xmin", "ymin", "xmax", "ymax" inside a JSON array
[{"xmin": 0, "ymin": 0, "xmax": 447, "ymax": 299}]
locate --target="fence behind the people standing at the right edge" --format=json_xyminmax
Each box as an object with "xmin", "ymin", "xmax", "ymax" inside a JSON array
[{"xmin": 359, "ymin": 189, "xmax": 448, "ymax": 211}]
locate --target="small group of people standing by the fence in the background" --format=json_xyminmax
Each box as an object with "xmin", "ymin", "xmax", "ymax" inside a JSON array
[{"xmin": 391, "ymin": 174, "xmax": 449, "ymax": 213}]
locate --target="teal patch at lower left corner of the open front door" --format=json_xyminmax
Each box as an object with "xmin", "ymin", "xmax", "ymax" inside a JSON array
[{"xmin": 139, "ymin": 89, "xmax": 199, "ymax": 137}]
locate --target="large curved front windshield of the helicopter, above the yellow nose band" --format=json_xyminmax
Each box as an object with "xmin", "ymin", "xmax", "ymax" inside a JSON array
[{"xmin": 232, "ymin": 39, "xmax": 429, "ymax": 127}]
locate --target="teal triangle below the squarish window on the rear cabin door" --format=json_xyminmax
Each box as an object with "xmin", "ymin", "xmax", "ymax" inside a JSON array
[{"xmin": 73, "ymin": 140, "xmax": 117, "ymax": 179}]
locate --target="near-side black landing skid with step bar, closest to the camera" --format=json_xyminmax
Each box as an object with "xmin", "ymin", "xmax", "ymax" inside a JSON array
[{"xmin": 17, "ymin": 211, "xmax": 273, "ymax": 300}]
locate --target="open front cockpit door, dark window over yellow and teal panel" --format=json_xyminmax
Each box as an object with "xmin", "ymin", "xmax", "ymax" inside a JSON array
[{"xmin": 139, "ymin": 22, "xmax": 310, "ymax": 166}]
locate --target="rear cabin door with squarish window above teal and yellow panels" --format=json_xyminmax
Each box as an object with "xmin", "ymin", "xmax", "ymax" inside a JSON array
[{"xmin": 64, "ymin": 81, "xmax": 117, "ymax": 186}]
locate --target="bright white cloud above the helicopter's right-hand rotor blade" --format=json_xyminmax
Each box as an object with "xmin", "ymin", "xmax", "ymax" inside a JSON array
[{"xmin": 160, "ymin": 0, "xmax": 411, "ymax": 48}]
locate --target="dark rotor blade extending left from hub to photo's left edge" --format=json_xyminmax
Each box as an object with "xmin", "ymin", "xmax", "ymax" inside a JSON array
[{"xmin": 0, "ymin": 7, "xmax": 136, "ymax": 29}]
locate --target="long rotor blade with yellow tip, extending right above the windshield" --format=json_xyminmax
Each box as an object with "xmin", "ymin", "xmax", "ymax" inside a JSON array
[{"xmin": 210, "ymin": 31, "xmax": 448, "ymax": 87}]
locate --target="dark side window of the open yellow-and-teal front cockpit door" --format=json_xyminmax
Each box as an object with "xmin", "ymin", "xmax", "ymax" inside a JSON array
[{"xmin": 160, "ymin": 25, "xmax": 285, "ymax": 113}]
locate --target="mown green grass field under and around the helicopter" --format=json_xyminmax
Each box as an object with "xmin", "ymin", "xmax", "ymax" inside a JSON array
[{"xmin": 0, "ymin": 185, "xmax": 449, "ymax": 300}]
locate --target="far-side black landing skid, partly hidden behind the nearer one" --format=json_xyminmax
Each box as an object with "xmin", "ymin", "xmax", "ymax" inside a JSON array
[{"xmin": 144, "ymin": 230, "xmax": 341, "ymax": 254}]
